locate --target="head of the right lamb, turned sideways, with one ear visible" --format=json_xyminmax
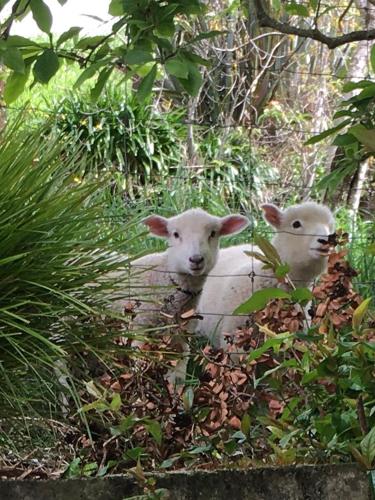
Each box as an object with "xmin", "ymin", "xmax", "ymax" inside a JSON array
[{"xmin": 263, "ymin": 202, "xmax": 334, "ymax": 276}]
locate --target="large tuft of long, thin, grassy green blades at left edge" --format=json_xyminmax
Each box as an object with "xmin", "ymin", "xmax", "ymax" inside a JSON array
[{"xmin": 0, "ymin": 115, "xmax": 142, "ymax": 415}]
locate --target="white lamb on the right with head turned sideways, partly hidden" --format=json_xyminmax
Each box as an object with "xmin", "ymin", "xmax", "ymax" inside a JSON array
[{"xmin": 196, "ymin": 202, "xmax": 334, "ymax": 348}]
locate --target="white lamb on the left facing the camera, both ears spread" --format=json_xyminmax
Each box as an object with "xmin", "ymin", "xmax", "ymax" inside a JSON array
[{"xmin": 123, "ymin": 209, "xmax": 249, "ymax": 383}]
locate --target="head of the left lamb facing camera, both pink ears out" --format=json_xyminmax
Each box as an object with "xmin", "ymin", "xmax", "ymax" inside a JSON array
[{"xmin": 143, "ymin": 209, "xmax": 249, "ymax": 276}]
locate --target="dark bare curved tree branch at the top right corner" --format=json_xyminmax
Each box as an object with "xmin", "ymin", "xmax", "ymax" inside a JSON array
[{"xmin": 254, "ymin": 0, "xmax": 375, "ymax": 49}]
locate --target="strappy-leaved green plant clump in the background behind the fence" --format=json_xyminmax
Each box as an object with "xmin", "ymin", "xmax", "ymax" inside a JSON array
[{"xmin": 46, "ymin": 89, "xmax": 181, "ymax": 184}]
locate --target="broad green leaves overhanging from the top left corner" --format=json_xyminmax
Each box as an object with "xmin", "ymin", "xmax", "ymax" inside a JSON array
[{"xmin": 0, "ymin": 0, "xmax": 219, "ymax": 104}]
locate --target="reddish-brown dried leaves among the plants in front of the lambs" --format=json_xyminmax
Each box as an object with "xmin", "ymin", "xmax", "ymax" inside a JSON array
[{"xmin": 68, "ymin": 245, "xmax": 370, "ymax": 463}]
